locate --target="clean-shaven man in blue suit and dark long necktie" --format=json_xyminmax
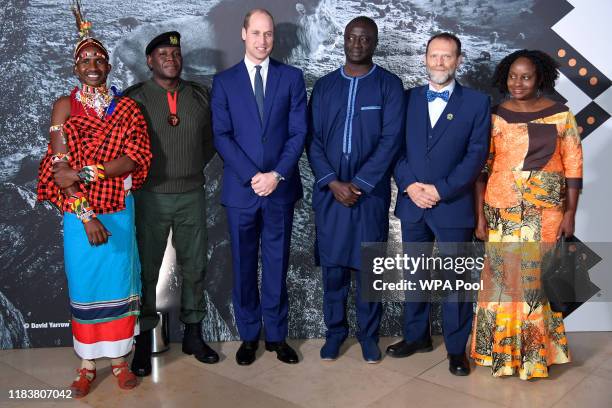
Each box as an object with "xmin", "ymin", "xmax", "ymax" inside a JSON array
[{"xmin": 211, "ymin": 9, "xmax": 308, "ymax": 365}]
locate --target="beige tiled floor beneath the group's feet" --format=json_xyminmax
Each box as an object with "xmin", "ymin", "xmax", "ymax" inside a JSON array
[{"xmin": 0, "ymin": 332, "xmax": 612, "ymax": 408}]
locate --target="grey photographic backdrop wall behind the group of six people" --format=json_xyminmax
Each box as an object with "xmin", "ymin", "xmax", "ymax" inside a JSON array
[{"xmin": 0, "ymin": 0, "xmax": 612, "ymax": 348}]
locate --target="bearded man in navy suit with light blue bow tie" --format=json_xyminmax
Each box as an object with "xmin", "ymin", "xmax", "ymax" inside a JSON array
[{"xmin": 387, "ymin": 33, "xmax": 490, "ymax": 375}]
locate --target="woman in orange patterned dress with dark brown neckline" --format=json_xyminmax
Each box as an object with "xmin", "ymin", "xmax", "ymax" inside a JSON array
[{"xmin": 471, "ymin": 50, "xmax": 582, "ymax": 380}]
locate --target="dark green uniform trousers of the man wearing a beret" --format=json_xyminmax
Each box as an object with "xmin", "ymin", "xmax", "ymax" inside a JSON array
[{"xmin": 134, "ymin": 189, "xmax": 207, "ymax": 331}]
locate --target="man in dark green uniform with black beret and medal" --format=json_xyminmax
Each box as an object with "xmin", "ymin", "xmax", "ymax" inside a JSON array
[{"xmin": 125, "ymin": 31, "xmax": 219, "ymax": 377}]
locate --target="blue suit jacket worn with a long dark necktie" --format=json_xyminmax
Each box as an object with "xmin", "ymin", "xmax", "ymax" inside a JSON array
[{"xmin": 211, "ymin": 59, "xmax": 308, "ymax": 208}]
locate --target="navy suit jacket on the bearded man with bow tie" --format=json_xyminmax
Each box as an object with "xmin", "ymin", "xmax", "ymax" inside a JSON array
[{"xmin": 394, "ymin": 83, "xmax": 491, "ymax": 228}]
